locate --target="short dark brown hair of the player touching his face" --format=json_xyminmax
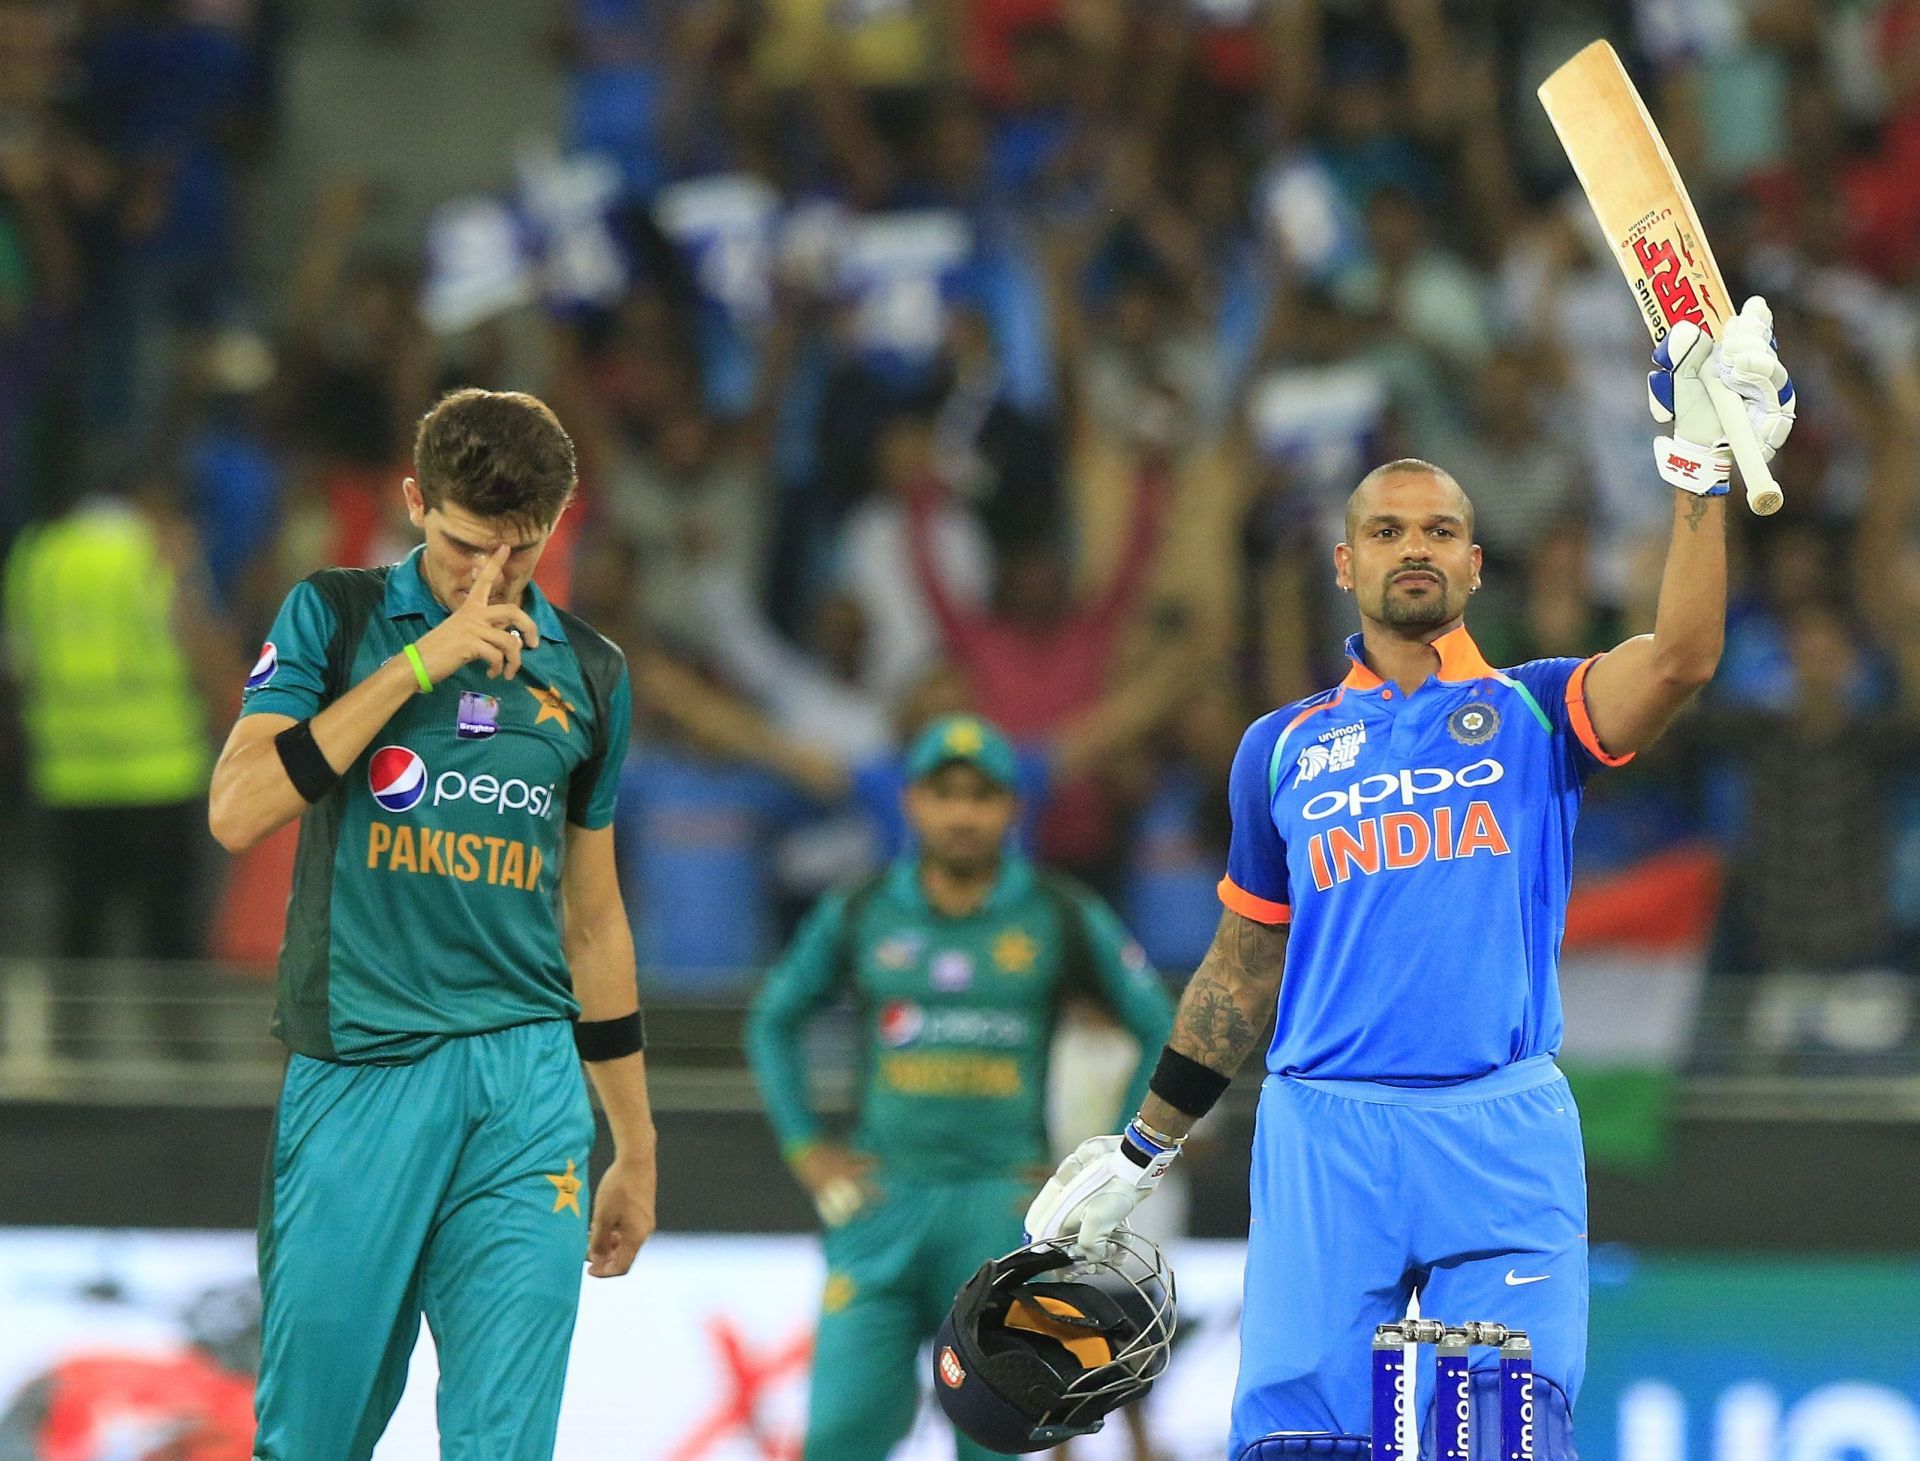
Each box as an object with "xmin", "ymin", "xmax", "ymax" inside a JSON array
[{"xmin": 413, "ymin": 386, "xmax": 576, "ymax": 530}]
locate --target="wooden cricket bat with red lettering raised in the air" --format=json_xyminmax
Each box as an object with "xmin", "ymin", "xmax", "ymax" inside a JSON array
[{"xmin": 1540, "ymin": 40, "xmax": 1782, "ymax": 516}]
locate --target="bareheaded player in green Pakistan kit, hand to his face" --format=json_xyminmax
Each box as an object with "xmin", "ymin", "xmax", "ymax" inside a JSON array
[{"xmin": 209, "ymin": 390, "xmax": 655, "ymax": 1461}]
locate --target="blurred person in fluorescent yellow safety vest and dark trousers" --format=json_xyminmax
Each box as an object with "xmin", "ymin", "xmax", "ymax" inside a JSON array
[{"xmin": 4, "ymin": 478, "xmax": 230, "ymax": 958}]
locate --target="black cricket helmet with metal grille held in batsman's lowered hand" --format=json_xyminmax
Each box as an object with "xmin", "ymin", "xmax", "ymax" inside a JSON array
[{"xmin": 933, "ymin": 1229, "xmax": 1175, "ymax": 1455}]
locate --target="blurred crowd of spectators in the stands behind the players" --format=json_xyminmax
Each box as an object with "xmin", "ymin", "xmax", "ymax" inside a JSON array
[{"xmin": 11, "ymin": 0, "xmax": 1920, "ymax": 991}]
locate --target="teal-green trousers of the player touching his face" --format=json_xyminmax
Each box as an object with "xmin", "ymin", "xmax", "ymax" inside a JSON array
[{"xmin": 253, "ymin": 1019, "xmax": 593, "ymax": 1461}]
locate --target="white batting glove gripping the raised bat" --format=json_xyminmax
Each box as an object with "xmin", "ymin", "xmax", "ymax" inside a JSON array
[{"xmin": 1647, "ymin": 296, "xmax": 1793, "ymax": 497}]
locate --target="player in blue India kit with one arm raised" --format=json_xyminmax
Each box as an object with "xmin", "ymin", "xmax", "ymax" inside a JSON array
[{"xmin": 1027, "ymin": 299, "xmax": 1793, "ymax": 1461}]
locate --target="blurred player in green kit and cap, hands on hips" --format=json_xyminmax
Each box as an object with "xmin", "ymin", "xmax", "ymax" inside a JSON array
[{"xmin": 747, "ymin": 716, "xmax": 1173, "ymax": 1461}]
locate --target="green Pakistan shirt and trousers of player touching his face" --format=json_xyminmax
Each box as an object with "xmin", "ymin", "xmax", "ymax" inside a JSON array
[{"xmin": 242, "ymin": 555, "xmax": 632, "ymax": 1461}]
